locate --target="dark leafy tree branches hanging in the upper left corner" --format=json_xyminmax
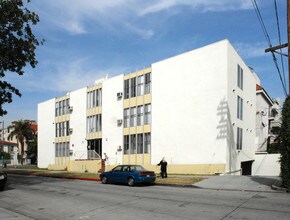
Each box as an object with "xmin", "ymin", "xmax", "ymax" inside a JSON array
[{"xmin": 0, "ymin": 0, "xmax": 43, "ymax": 116}]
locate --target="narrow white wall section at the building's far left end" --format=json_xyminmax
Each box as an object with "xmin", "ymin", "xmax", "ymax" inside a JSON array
[{"xmin": 37, "ymin": 99, "xmax": 55, "ymax": 168}]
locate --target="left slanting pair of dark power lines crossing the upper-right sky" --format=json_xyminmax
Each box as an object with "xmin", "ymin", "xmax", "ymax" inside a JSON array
[{"xmin": 252, "ymin": 0, "xmax": 287, "ymax": 96}]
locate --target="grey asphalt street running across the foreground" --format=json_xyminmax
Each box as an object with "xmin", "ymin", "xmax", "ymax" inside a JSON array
[{"xmin": 0, "ymin": 175, "xmax": 290, "ymax": 220}]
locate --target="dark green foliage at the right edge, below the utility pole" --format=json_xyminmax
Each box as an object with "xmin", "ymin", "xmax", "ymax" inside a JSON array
[{"xmin": 279, "ymin": 96, "xmax": 290, "ymax": 188}]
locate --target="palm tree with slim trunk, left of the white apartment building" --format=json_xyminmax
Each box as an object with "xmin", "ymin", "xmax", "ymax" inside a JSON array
[{"xmin": 8, "ymin": 120, "xmax": 35, "ymax": 165}]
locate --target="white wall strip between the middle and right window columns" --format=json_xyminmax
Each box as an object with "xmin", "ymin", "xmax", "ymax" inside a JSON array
[{"xmin": 102, "ymin": 75, "xmax": 124, "ymax": 164}]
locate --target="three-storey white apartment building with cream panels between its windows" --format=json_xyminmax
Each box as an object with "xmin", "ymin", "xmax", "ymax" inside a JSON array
[{"xmin": 38, "ymin": 40, "xmax": 260, "ymax": 174}]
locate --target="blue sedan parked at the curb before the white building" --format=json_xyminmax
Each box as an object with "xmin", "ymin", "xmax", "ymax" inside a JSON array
[{"xmin": 100, "ymin": 165, "xmax": 156, "ymax": 186}]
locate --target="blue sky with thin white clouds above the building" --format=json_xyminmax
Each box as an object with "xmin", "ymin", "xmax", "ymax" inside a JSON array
[{"xmin": 1, "ymin": 0, "xmax": 288, "ymax": 126}]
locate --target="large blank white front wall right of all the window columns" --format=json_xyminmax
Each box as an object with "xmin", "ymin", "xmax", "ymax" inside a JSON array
[{"xmin": 152, "ymin": 41, "xmax": 228, "ymax": 164}]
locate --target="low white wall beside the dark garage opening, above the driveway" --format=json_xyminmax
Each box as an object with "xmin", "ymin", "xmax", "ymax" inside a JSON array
[{"xmin": 252, "ymin": 154, "xmax": 280, "ymax": 176}]
